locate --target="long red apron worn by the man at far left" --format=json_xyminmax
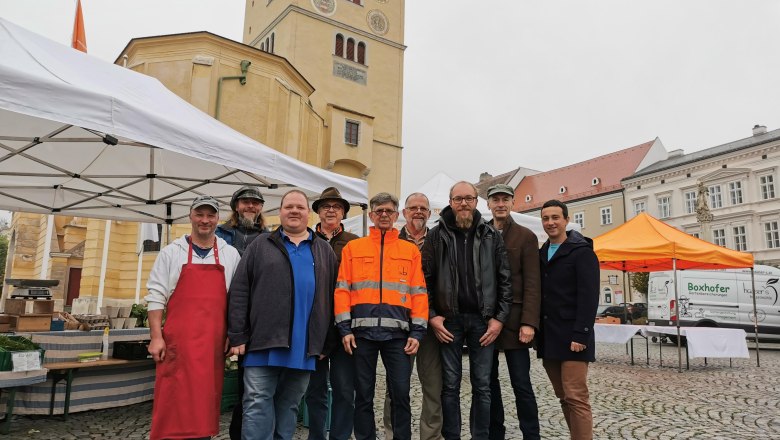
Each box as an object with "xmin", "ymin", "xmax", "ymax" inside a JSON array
[{"xmin": 150, "ymin": 238, "xmax": 227, "ymax": 440}]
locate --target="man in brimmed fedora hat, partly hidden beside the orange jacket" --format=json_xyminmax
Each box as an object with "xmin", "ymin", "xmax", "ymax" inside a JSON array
[{"xmin": 306, "ymin": 187, "xmax": 358, "ymax": 440}]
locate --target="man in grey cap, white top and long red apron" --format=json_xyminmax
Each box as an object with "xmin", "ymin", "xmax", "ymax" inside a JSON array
[{"xmin": 146, "ymin": 196, "xmax": 240, "ymax": 440}]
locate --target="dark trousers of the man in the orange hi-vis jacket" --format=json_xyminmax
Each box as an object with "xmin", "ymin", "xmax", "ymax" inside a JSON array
[{"xmin": 352, "ymin": 338, "xmax": 412, "ymax": 440}]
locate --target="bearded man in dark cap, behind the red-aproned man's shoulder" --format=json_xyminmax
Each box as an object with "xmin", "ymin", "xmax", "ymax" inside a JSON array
[{"xmin": 217, "ymin": 185, "xmax": 265, "ymax": 255}]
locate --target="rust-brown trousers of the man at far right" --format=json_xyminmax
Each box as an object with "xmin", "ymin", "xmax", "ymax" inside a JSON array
[{"xmin": 542, "ymin": 359, "xmax": 593, "ymax": 440}]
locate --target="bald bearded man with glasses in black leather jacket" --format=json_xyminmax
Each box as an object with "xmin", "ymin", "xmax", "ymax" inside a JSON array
[{"xmin": 422, "ymin": 182, "xmax": 512, "ymax": 440}]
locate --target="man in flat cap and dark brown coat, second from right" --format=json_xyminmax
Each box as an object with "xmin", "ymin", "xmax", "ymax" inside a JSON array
[{"xmin": 488, "ymin": 185, "xmax": 541, "ymax": 440}]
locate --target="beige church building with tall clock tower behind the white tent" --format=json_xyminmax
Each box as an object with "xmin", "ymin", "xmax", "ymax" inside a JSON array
[{"xmin": 6, "ymin": 0, "xmax": 405, "ymax": 310}]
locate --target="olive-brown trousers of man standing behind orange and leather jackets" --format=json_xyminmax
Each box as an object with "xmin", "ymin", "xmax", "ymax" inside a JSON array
[{"xmin": 383, "ymin": 327, "xmax": 444, "ymax": 440}]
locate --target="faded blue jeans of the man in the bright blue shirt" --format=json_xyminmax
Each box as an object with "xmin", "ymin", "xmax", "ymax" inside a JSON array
[{"xmin": 241, "ymin": 367, "xmax": 311, "ymax": 440}]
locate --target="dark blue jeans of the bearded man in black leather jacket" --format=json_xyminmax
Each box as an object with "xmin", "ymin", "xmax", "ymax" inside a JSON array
[{"xmin": 441, "ymin": 313, "xmax": 495, "ymax": 440}]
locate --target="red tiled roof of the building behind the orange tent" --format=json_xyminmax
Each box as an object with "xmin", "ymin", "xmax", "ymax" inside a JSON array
[{"xmin": 514, "ymin": 140, "xmax": 655, "ymax": 212}]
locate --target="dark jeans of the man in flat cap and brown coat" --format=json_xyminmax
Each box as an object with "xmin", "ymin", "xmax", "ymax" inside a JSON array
[{"xmin": 489, "ymin": 348, "xmax": 541, "ymax": 440}]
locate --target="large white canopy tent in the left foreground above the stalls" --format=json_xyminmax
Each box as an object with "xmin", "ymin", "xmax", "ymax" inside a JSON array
[{"xmin": 0, "ymin": 18, "xmax": 368, "ymax": 306}]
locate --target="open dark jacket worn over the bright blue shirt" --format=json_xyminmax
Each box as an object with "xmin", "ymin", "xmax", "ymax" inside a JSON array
[{"xmin": 228, "ymin": 229, "xmax": 337, "ymax": 356}]
